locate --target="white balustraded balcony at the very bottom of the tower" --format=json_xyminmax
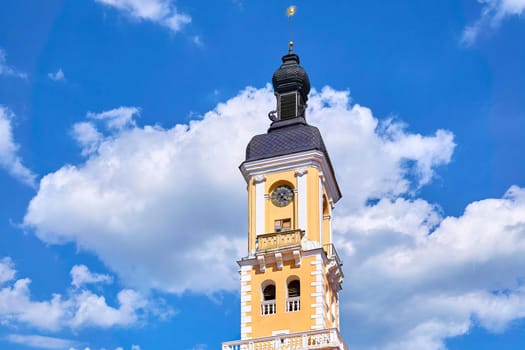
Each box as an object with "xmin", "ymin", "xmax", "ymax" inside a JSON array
[{"xmin": 222, "ymin": 328, "xmax": 348, "ymax": 350}]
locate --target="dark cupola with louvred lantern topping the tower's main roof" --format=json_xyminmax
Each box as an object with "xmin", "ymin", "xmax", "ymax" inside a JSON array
[{"xmin": 270, "ymin": 46, "xmax": 310, "ymax": 121}]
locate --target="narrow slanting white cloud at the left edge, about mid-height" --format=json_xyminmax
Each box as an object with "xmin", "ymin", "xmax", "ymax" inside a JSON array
[{"xmin": 0, "ymin": 105, "xmax": 36, "ymax": 187}]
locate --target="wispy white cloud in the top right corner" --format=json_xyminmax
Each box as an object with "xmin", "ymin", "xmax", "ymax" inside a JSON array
[{"xmin": 461, "ymin": 0, "xmax": 525, "ymax": 45}]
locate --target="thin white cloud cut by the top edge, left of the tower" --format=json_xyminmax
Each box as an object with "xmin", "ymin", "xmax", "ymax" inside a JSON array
[{"xmin": 95, "ymin": 0, "xmax": 191, "ymax": 32}]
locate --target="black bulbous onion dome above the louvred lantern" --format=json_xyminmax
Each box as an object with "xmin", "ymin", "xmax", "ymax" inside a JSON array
[{"xmin": 272, "ymin": 52, "xmax": 310, "ymax": 102}]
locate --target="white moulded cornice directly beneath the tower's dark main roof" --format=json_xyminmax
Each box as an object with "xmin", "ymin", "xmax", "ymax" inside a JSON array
[{"xmin": 239, "ymin": 150, "xmax": 341, "ymax": 203}]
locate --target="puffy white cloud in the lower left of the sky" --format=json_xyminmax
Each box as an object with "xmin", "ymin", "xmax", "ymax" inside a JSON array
[{"xmin": 0, "ymin": 259, "xmax": 151, "ymax": 332}]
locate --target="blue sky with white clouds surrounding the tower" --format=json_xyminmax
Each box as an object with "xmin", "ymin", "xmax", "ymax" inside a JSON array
[{"xmin": 0, "ymin": 0, "xmax": 525, "ymax": 350}]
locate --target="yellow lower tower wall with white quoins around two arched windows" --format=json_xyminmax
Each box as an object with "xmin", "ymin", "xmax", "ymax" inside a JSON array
[{"xmin": 240, "ymin": 249, "xmax": 338, "ymax": 339}]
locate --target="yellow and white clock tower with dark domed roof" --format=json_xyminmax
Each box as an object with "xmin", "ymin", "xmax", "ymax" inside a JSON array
[{"xmin": 222, "ymin": 45, "xmax": 347, "ymax": 350}]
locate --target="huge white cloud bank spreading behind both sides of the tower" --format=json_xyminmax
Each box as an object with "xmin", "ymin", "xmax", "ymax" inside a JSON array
[{"xmin": 24, "ymin": 86, "xmax": 525, "ymax": 350}]
